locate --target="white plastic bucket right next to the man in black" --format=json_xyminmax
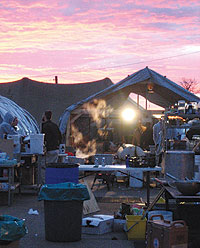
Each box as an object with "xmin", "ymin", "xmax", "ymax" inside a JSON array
[{"xmin": 30, "ymin": 134, "xmax": 44, "ymax": 154}]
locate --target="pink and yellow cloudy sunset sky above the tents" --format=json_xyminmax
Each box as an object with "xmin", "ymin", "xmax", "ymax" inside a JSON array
[{"xmin": 0, "ymin": 0, "xmax": 200, "ymax": 86}]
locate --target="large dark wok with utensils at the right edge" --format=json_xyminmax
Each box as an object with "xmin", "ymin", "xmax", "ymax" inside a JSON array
[{"xmin": 166, "ymin": 173, "xmax": 200, "ymax": 195}]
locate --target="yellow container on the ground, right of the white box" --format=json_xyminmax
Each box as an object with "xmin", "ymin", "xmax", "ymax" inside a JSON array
[{"xmin": 126, "ymin": 215, "xmax": 147, "ymax": 240}]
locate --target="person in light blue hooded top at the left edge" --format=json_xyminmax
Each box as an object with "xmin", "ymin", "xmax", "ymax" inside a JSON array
[{"xmin": 0, "ymin": 112, "xmax": 18, "ymax": 139}]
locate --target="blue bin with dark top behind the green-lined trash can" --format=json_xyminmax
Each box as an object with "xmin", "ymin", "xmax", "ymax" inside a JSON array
[{"xmin": 45, "ymin": 163, "xmax": 79, "ymax": 184}]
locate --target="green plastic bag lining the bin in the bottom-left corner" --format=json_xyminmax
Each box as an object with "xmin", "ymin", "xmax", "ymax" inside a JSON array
[{"xmin": 0, "ymin": 215, "xmax": 28, "ymax": 241}]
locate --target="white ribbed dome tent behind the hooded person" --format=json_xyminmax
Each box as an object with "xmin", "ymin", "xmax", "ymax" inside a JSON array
[{"xmin": 0, "ymin": 96, "xmax": 40, "ymax": 136}]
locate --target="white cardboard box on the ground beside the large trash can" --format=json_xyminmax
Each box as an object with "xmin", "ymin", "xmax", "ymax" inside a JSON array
[{"xmin": 82, "ymin": 215, "xmax": 114, "ymax": 234}]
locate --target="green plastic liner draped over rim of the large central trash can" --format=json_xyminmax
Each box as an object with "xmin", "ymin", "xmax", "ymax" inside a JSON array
[{"xmin": 38, "ymin": 182, "xmax": 90, "ymax": 201}]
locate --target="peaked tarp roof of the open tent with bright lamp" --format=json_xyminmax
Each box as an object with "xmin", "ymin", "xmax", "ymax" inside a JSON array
[{"xmin": 60, "ymin": 67, "xmax": 200, "ymax": 134}]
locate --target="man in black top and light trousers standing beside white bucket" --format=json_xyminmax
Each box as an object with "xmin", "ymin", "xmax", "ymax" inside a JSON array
[{"xmin": 42, "ymin": 110, "xmax": 62, "ymax": 163}]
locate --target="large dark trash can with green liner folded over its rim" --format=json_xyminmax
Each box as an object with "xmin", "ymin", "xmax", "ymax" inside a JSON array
[{"xmin": 38, "ymin": 182, "xmax": 90, "ymax": 242}]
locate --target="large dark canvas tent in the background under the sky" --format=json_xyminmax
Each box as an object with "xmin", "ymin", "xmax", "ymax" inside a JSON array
[{"xmin": 0, "ymin": 77, "xmax": 113, "ymax": 124}]
